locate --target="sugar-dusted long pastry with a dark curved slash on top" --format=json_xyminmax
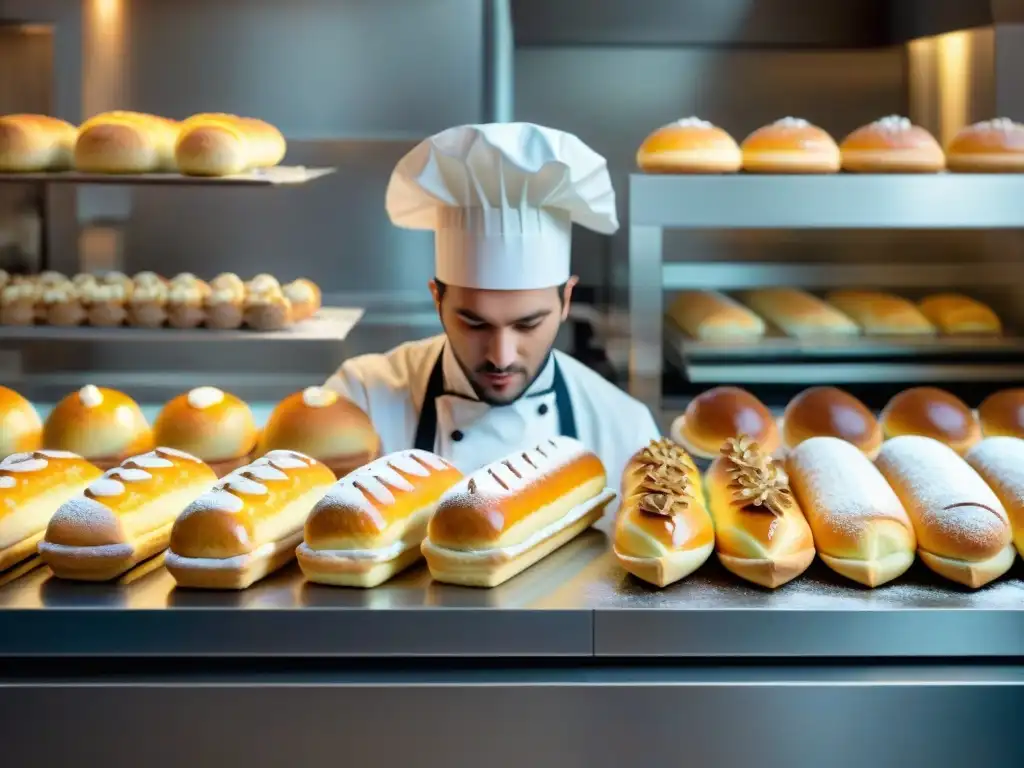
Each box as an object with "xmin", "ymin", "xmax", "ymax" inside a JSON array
[{"xmin": 877, "ymin": 435, "xmax": 1016, "ymax": 588}]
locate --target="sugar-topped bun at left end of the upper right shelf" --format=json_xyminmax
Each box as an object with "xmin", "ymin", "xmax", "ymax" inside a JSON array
[{"xmin": 637, "ymin": 118, "xmax": 742, "ymax": 173}]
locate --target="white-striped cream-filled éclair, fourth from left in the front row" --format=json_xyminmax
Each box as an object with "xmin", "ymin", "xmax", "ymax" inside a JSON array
[{"xmin": 296, "ymin": 451, "xmax": 462, "ymax": 587}]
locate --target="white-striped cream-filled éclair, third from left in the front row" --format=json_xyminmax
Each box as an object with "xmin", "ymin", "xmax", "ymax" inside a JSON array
[{"xmin": 164, "ymin": 451, "xmax": 335, "ymax": 590}]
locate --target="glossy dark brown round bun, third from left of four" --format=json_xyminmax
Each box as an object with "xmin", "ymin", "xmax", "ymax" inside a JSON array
[{"xmin": 881, "ymin": 387, "xmax": 981, "ymax": 454}]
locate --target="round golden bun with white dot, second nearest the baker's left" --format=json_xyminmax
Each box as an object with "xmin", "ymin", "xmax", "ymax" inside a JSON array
[{"xmin": 153, "ymin": 387, "xmax": 259, "ymax": 476}]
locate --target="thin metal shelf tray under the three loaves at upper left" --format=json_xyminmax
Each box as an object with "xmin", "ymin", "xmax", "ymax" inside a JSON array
[{"xmin": 0, "ymin": 166, "xmax": 335, "ymax": 186}]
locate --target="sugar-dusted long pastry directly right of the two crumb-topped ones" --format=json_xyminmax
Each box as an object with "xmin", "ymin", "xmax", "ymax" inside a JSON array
[{"xmin": 785, "ymin": 437, "xmax": 918, "ymax": 587}]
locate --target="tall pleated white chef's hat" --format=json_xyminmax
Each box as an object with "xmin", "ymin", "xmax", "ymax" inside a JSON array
[{"xmin": 387, "ymin": 123, "xmax": 618, "ymax": 291}]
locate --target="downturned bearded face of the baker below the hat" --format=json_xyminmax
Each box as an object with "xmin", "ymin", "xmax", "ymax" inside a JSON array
[{"xmin": 430, "ymin": 278, "xmax": 577, "ymax": 406}]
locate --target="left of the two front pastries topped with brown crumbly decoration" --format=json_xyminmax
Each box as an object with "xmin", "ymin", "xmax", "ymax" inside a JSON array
[{"xmin": 612, "ymin": 439, "xmax": 715, "ymax": 587}]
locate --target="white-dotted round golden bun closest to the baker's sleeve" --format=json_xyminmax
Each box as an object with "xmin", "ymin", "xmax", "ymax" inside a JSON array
[{"xmin": 259, "ymin": 387, "xmax": 381, "ymax": 477}]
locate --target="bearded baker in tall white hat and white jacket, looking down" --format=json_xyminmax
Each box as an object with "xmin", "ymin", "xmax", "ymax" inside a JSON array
[{"xmin": 325, "ymin": 123, "xmax": 659, "ymax": 480}]
